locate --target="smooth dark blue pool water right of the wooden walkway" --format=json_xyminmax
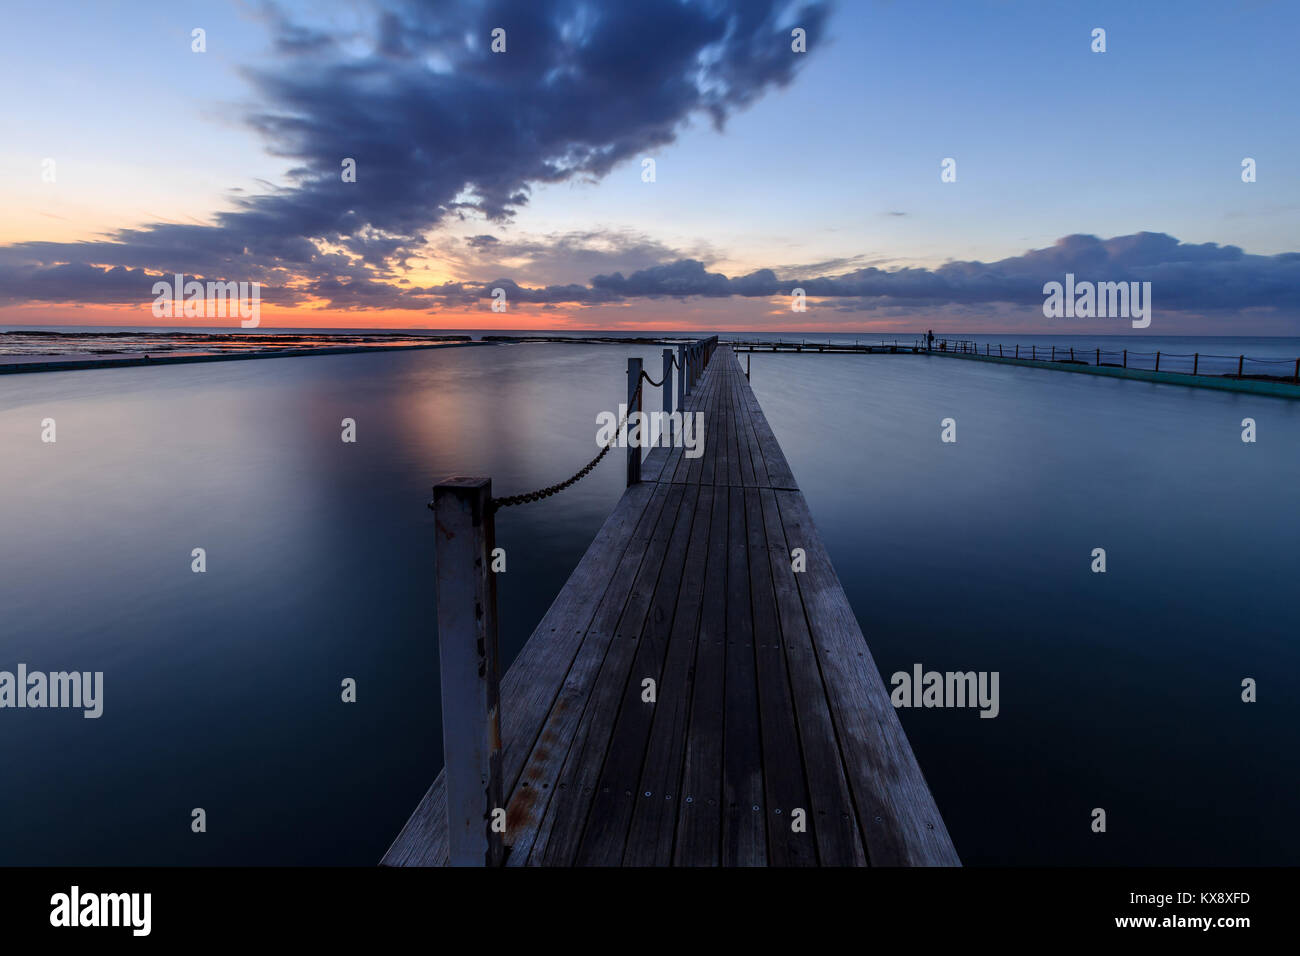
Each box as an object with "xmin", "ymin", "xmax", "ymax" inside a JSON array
[{"xmin": 751, "ymin": 355, "xmax": 1300, "ymax": 865}]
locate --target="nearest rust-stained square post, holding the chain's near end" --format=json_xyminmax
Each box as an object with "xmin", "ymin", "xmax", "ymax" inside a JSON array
[{"xmin": 433, "ymin": 477, "xmax": 504, "ymax": 866}]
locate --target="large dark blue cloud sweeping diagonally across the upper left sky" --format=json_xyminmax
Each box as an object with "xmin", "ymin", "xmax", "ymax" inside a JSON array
[{"xmin": 0, "ymin": 0, "xmax": 827, "ymax": 302}]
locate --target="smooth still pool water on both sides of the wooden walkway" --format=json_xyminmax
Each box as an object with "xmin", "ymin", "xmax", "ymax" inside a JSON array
[{"xmin": 0, "ymin": 345, "xmax": 1300, "ymax": 865}]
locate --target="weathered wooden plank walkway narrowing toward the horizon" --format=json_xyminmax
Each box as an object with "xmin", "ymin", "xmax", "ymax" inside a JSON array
[{"xmin": 382, "ymin": 346, "xmax": 959, "ymax": 866}]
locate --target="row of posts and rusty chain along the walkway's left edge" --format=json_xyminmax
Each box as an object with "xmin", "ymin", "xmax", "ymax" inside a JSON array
[{"xmin": 429, "ymin": 336, "xmax": 718, "ymax": 866}]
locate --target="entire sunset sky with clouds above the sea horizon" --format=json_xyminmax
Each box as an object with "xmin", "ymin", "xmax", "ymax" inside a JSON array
[{"xmin": 0, "ymin": 0, "xmax": 1300, "ymax": 334}]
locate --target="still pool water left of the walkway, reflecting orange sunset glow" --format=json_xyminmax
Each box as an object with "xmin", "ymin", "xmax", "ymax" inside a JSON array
[{"xmin": 0, "ymin": 346, "xmax": 659, "ymax": 865}]
